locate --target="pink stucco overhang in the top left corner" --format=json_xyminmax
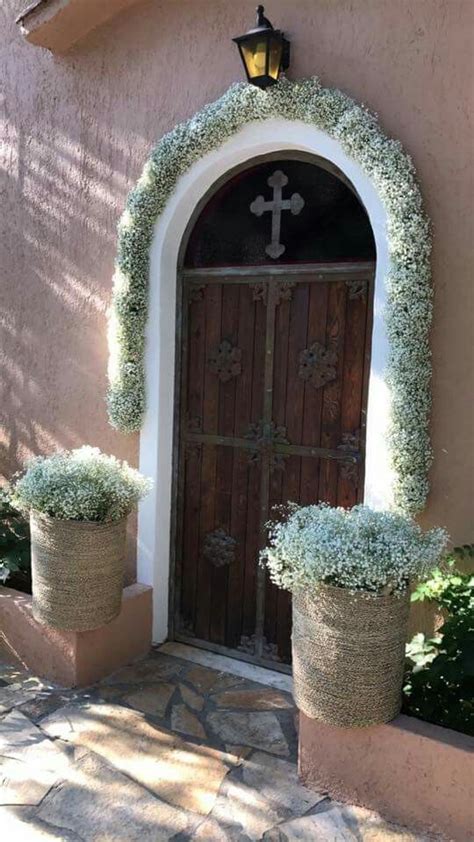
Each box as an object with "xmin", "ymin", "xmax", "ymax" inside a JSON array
[{"xmin": 16, "ymin": 0, "xmax": 142, "ymax": 54}]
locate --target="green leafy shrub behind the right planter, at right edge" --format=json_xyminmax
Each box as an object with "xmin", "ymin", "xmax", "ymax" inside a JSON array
[{"xmin": 404, "ymin": 545, "xmax": 474, "ymax": 735}]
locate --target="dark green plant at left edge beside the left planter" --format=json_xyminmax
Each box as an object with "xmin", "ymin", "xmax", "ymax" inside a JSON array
[{"xmin": 0, "ymin": 488, "xmax": 30, "ymax": 583}]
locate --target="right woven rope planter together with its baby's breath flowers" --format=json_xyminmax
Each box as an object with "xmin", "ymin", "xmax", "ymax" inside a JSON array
[{"xmin": 261, "ymin": 503, "xmax": 448, "ymax": 727}]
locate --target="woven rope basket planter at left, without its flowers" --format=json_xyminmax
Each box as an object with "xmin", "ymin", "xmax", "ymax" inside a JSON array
[{"xmin": 30, "ymin": 512, "xmax": 127, "ymax": 631}]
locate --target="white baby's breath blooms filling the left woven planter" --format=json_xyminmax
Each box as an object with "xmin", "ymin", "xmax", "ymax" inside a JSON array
[{"xmin": 12, "ymin": 447, "xmax": 151, "ymax": 523}]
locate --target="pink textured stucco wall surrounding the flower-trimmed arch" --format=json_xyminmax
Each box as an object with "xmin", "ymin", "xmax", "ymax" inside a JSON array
[{"xmin": 0, "ymin": 0, "xmax": 474, "ymax": 560}]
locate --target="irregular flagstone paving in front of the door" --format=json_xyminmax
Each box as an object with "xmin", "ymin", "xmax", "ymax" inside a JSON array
[{"xmin": 0, "ymin": 650, "xmax": 436, "ymax": 842}]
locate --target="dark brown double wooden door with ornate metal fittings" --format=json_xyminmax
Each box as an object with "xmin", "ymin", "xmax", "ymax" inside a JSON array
[{"xmin": 173, "ymin": 263, "xmax": 374, "ymax": 670}]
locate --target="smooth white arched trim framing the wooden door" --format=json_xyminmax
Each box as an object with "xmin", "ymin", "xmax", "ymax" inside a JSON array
[{"xmin": 137, "ymin": 118, "xmax": 394, "ymax": 642}]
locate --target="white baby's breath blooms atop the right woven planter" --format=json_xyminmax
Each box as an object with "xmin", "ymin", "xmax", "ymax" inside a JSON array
[{"xmin": 261, "ymin": 503, "xmax": 448, "ymax": 593}]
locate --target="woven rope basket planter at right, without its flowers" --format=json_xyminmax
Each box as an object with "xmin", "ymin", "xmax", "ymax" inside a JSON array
[{"xmin": 292, "ymin": 585, "xmax": 409, "ymax": 728}]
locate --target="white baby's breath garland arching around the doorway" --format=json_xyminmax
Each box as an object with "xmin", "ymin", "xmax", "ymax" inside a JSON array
[{"xmin": 108, "ymin": 79, "xmax": 432, "ymax": 514}]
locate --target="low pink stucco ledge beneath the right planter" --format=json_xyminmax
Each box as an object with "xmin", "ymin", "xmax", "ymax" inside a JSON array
[{"xmin": 299, "ymin": 713, "xmax": 474, "ymax": 842}]
